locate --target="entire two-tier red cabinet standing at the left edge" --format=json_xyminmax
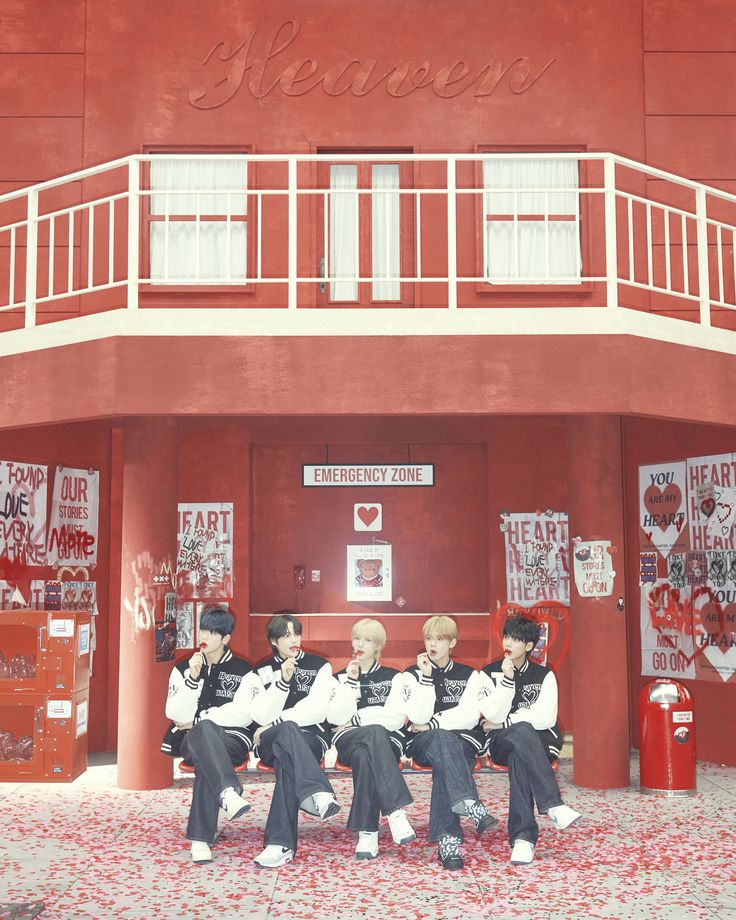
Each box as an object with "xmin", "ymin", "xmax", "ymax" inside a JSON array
[{"xmin": 0, "ymin": 610, "xmax": 91, "ymax": 782}]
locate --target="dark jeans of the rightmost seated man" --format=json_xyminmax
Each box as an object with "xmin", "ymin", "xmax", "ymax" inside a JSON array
[{"xmin": 488, "ymin": 722, "xmax": 562, "ymax": 846}]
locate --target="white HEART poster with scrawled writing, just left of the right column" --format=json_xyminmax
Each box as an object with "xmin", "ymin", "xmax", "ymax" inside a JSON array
[{"xmin": 504, "ymin": 511, "xmax": 570, "ymax": 607}]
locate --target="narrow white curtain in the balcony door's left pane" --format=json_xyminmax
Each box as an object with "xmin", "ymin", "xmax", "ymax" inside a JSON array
[{"xmin": 329, "ymin": 163, "xmax": 358, "ymax": 300}]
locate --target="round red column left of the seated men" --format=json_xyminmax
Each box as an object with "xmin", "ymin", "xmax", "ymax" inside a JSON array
[{"xmin": 118, "ymin": 419, "xmax": 178, "ymax": 789}]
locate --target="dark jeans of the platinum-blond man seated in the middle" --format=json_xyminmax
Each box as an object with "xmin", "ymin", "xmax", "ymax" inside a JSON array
[{"xmin": 335, "ymin": 725, "xmax": 414, "ymax": 831}]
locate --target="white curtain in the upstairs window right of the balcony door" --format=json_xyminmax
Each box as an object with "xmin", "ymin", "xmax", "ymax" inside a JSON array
[{"xmin": 483, "ymin": 159, "xmax": 581, "ymax": 284}]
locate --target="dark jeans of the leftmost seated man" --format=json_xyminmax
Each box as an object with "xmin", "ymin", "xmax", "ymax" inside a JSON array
[{"xmin": 181, "ymin": 719, "xmax": 248, "ymax": 846}]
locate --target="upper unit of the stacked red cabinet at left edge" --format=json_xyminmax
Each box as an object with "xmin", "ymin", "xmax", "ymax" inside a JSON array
[{"xmin": 0, "ymin": 610, "xmax": 91, "ymax": 693}]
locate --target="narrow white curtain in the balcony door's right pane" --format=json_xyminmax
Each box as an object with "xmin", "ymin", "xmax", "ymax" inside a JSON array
[{"xmin": 371, "ymin": 163, "xmax": 401, "ymax": 300}]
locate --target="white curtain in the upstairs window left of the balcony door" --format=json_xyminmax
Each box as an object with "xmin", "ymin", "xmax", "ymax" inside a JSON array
[{"xmin": 150, "ymin": 159, "xmax": 247, "ymax": 281}]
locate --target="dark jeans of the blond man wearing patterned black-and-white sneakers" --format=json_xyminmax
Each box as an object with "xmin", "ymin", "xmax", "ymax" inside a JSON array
[{"xmin": 410, "ymin": 728, "xmax": 478, "ymax": 842}]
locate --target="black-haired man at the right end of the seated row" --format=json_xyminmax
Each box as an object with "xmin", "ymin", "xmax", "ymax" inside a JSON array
[{"xmin": 478, "ymin": 616, "xmax": 581, "ymax": 865}]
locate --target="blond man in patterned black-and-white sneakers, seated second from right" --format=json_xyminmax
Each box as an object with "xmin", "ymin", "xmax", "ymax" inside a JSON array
[{"xmin": 405, "ymin": 616, "xmax": 498, "ymax": 869}]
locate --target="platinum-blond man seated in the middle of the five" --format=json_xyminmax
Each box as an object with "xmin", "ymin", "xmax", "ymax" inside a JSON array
[{"xmin": 328, "ymin": 619, "xmax": 416, "ymax": 859}]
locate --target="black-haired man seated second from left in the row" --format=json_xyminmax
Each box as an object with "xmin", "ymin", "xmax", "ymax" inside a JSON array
[{"xmin": 253, "ymin": 610, "xmax": 340, "ymax": 869}]
